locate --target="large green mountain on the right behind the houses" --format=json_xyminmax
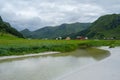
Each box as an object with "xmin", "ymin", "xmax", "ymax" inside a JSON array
[{"xmin": 70, "ymin": 14, "xmax": 120, "ymax": 39}]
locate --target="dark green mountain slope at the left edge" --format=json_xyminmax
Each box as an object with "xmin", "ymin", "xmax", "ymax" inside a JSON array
[{"xmin": 0, "ymin": 16, "xmax": 23, "ymax": 38}]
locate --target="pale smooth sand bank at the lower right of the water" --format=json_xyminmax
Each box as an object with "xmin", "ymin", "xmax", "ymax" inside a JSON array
[{"xmin": 57, "ymin": 47, "xmax": 120, "ymax": 80}]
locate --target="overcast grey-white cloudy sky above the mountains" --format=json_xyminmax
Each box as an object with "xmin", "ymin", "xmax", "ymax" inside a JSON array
[{"xmin": 0, "ymin": 0, "xmax": 120, "ymax": 30}]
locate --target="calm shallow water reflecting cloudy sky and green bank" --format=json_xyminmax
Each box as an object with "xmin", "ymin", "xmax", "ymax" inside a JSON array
[{"xmin": 0, "ymin": 49, "xmax": 109, "ymax": 80}]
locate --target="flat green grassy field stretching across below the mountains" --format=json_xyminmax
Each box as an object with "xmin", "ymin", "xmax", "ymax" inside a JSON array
[{"xmin": 0, "ymin": 35, "xmax": 120, "ymax": 56}]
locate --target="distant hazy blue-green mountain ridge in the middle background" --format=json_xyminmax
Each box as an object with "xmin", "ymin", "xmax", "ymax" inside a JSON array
[{"xmin": 21, "ymin": 22, "xmax": 91, "ymax": 39}]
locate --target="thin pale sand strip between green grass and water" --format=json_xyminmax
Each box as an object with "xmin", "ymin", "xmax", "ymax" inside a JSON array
[{"xmin": 0, "ymin": 52, "xmax": 60, "ymax": 60}]
